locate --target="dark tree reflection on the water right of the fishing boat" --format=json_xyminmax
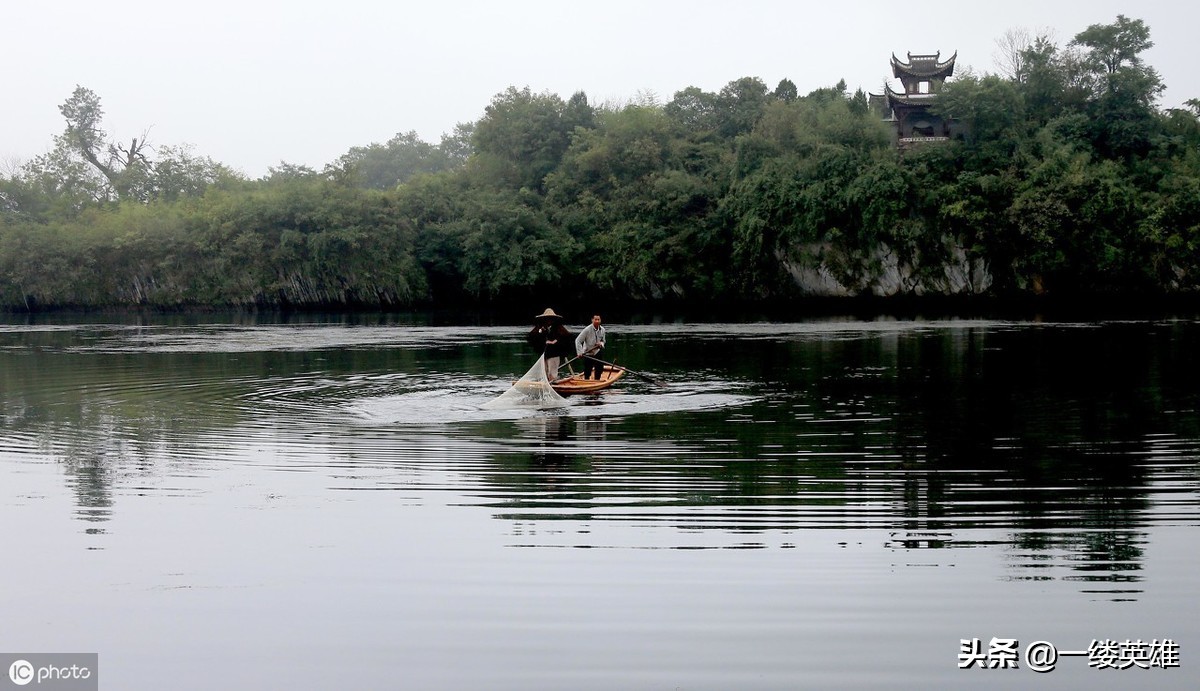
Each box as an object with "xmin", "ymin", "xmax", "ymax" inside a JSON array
[{"xmin": 468, "ymin": 325, "xmax": 1198, "ymax": 594}]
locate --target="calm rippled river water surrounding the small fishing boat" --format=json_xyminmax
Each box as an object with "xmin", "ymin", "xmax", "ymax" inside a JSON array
[{"xmin": 0, "ymin": 317, "xmax": 1200, "ymax": 690}]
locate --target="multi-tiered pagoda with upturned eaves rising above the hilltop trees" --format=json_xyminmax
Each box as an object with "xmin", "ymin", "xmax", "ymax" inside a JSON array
[{"xmin": 870, "ymin": 50, "xmax": 959, "ymax": 149}]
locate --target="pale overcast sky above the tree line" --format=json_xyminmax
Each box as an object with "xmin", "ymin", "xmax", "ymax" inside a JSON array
[{"xmin": 0, "ymin": 0, "xmax": 1200, "ymax": 178}]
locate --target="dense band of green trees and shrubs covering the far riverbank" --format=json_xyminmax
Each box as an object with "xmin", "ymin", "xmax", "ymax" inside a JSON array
[{"xmin": 0, "ymin": 17, "xmax": 1200, "ymax": 310}]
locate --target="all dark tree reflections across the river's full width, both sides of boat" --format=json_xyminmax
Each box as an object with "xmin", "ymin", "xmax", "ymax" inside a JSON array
[{"xmin": 0, "ymin": 316, "xmax": 1200, "ymax": 593}]
